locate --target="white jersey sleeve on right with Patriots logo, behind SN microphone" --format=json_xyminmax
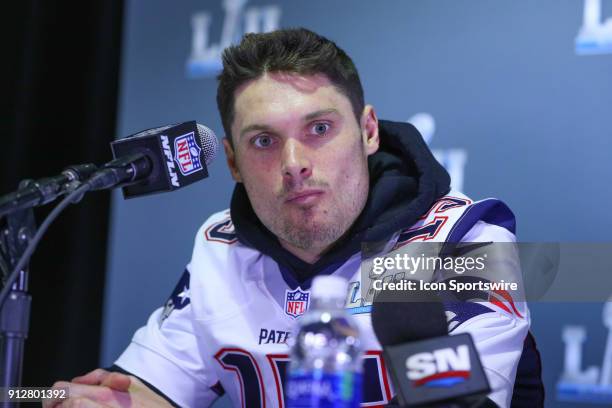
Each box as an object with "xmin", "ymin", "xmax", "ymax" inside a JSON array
[{"xmin": 445, "ymin": 220, "xmax": 530, "ymax": 407}]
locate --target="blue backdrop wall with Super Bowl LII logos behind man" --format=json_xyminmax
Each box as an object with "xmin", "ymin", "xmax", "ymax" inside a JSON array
[{"xmin": 101, "ymin": 0, "xmax": 612, "ymax": 407}]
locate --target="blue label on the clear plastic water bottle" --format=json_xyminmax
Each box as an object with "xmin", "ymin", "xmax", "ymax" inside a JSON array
[{"xmin": 285, "ymin": 371, "xmax": 362, "ymax": 408}]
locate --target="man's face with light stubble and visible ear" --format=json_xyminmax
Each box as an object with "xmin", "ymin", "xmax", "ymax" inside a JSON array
[{"xmin": 224, "ymin": 73, "xmax": 378, "ymax": 261}]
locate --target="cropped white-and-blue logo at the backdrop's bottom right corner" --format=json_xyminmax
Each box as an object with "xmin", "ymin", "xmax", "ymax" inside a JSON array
[{"xmin": 557, "ymin": 299, "xmax": 612, "ymax": 406}]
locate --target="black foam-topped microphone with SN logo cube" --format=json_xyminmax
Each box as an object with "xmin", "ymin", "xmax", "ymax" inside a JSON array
[{"xmin": 371, "ymin": 290, "xmax": 497, "ymax": 408}]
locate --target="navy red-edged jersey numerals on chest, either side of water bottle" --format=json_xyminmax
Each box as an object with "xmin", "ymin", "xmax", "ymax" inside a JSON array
[{"xmin": 215, "ymin": 348, "xmax": 391, "ymax": 407}]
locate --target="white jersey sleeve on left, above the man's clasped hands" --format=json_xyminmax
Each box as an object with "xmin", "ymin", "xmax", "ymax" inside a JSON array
[{"xmin": 115, "ymin": 266, "xmax": 220, "ymax": 407}]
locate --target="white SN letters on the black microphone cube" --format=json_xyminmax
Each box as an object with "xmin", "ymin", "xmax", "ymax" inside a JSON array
[{"xmin": 406, "ymin": 344, "xmax": 471, "ymax": 385}]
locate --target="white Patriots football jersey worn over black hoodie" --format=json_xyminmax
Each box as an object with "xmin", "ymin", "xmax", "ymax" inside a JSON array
[{"xmin": 115, "ymin": 194, "xmax": 530, "ymax": 407}]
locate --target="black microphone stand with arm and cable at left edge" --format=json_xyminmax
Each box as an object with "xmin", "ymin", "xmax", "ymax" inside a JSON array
[{"xmin": 0, "ymin": 158, "xmax": 152, "ymax": 408}]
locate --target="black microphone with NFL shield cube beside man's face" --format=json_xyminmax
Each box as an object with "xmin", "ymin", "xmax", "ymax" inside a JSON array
[{"xmin": 87, "ymin": 121, "xmax": 219, "ymax": 198}]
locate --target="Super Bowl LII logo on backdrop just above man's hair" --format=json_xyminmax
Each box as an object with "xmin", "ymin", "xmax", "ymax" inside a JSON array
[{"xmin": 187, "ymin": 0, "xmax": 281, "ymax": 78}]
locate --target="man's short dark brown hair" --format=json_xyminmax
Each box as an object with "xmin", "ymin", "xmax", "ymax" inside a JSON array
[{"xmin": 217, "ymin": 28, "xmax": 364, "ymax": 143}]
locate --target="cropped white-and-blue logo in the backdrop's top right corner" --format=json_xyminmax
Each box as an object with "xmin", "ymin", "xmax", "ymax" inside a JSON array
[{"xmin": 576, "ymin": 0, "xmax": 612, "ymax": 55}]
